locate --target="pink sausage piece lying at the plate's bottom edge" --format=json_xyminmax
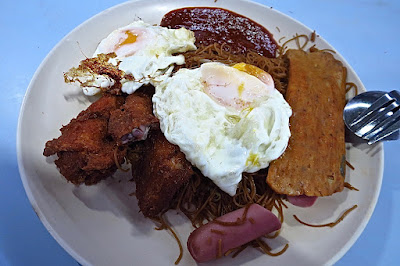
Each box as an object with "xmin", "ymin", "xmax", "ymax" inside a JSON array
[{"xmin": 187, "ymin": 204, "xmax": 281, "ymax": 262}]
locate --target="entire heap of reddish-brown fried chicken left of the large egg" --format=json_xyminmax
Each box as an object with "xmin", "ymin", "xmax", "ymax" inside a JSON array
[{"xmin": 43, "ymin": 86, "xmax": 193, "ymax": 217}]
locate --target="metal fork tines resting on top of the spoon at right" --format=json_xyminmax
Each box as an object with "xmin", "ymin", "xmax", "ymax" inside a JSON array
[{"xmin": 349, "ymin": 90, "xmax": 400, "ymax": 144}]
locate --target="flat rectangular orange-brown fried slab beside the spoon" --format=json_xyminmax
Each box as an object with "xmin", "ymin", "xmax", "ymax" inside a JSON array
[{"xmin": 267, "ymin": 50, "xmax": 346, "ymax": 196}]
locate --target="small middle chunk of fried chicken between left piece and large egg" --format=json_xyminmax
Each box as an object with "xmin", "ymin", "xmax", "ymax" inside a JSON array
[{"xmin": 108, "ymin": 92, "xmax": 158, "ymax": 145}]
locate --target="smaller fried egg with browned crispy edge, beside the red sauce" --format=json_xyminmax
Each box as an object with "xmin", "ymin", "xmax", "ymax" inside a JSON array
[{"xmin": 75, "ymin": 20, "xmax": 196, "ymax": 95}]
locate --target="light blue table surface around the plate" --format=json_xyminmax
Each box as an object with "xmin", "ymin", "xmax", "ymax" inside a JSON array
[{"xmin": 0, "ymin": 0, "xmax": 400, "ymax": 265}]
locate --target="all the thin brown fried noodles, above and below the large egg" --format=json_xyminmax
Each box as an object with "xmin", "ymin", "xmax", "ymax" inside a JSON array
[{"xmin": 130, "ymin": 40, "xmax": 357, "ymax": 264}]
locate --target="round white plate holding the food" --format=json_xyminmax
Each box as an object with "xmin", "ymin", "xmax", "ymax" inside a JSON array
[{"xmin": 17, "ymin": 0, "xmax": 383, "ymax": 265}]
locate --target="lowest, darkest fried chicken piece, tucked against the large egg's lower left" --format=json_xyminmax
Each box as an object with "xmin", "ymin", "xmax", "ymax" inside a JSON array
[{"xmin": 132, "ymin": 130, "xmax": 193, "ymax": 217}]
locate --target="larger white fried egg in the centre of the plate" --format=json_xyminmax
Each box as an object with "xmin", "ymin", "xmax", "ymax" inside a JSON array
[{"xmin": 153, "ymin": 63, "xmax": 292, "ymax": 196}]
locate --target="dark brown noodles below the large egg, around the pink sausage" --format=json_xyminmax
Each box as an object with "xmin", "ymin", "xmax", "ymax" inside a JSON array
[{"xmin": 172, "ymin": 170, "xmax": 288, "ymax": 257}]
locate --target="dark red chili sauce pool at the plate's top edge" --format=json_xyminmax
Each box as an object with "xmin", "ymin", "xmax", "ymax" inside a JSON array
[{"xmin": 160, "ymin": 7, "xmax": 278, "ymax": 58}]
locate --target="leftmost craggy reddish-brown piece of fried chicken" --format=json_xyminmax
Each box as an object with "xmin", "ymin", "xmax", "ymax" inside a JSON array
[{"xmin": 43, "ymin": 95, "xmax": 126, "ymax": 185}]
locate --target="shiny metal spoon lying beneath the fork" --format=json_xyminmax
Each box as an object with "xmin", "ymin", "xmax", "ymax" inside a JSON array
[{"xmin": 343, "ymin": 91, "xmax": 400, "ymax": 142}]
